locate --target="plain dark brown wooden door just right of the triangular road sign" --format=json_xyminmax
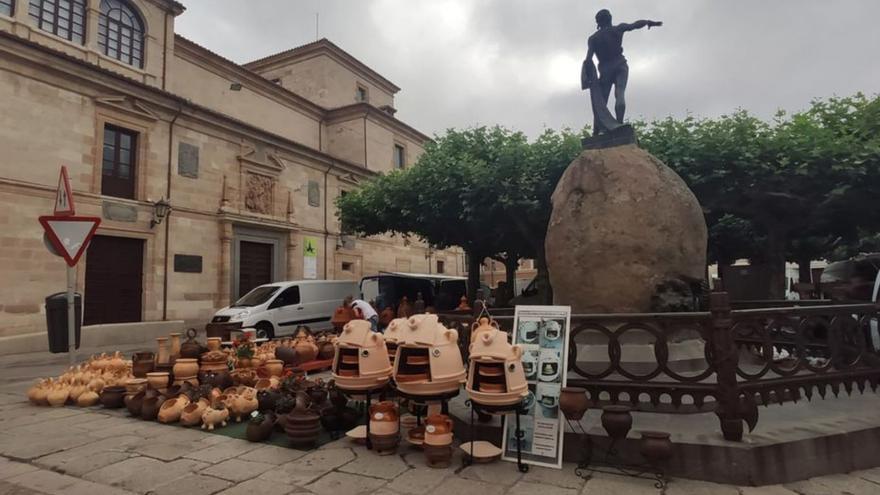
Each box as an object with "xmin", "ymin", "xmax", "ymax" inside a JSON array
[{"xmin": 83, "ymin": 235, "xmax": 144, "ymax": 325}]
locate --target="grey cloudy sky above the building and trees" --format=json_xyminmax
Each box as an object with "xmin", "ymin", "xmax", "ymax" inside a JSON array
[{"xmin": 176, "ymin": 0, "xmax": 880, "ymax": 136}]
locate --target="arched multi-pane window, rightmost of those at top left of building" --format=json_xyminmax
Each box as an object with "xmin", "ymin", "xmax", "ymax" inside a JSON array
[{"xmin": 98, "ymin": 0, "xmax": 144, "ymax": 68}]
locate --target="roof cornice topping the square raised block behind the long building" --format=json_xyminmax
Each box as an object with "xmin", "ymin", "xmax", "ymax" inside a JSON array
[{"xmin": 243, "ymin": 38, "xmax": 400, "ymax": 95}]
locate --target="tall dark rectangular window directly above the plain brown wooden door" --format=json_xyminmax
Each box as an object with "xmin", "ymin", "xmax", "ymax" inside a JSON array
[{"xmin": 101, "ymin": 124, "xmax": 137, "ymax": 199}]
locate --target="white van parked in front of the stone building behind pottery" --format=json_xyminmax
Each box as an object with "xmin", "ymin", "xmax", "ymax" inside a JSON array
[{"xmin": 211, "ymin": 280, "xmax": 359, "ymax": 338}]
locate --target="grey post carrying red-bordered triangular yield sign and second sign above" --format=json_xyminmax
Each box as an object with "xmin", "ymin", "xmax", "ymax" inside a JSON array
[{"xmin": 39, "ymin": 166, "xmax": 101, "ymax": 366}]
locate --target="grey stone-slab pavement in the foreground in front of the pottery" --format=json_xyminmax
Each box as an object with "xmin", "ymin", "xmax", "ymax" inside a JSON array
[{"xmin": 0, "ymin": 393, "xmax": 880, "ymax": 495}]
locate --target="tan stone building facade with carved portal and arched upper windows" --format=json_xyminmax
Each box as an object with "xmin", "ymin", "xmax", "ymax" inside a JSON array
[{"xmin": 0, "ymin": 0, "xmax": 464, "ymax": 338}]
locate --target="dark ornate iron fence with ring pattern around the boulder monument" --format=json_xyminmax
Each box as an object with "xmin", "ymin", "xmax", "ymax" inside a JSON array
[{"xmin": 441, "ymin": 292, "xmax": 880, "ymax": 441}]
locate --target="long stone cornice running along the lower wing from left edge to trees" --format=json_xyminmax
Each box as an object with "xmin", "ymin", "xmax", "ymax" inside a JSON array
[{"xmin": 0, "ymin": 31, "xmax": 376, "ymax": 177}]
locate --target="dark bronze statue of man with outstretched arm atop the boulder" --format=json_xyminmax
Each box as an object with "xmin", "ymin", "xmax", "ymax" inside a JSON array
[{"xmin": 581, "ymin": 9, "xmax": 663, "ymax": 135}]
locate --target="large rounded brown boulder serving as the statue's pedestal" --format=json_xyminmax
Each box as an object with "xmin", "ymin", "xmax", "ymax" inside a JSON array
[{"xmin": 545, "ymin": 145, "xmax": 707, "ymax": 313}]
